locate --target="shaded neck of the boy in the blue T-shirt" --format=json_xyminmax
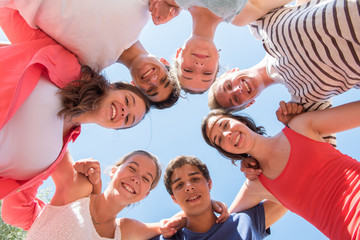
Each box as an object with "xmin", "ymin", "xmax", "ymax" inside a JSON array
[{"xmin": 186, "ymin": 207, "xmax": 216, "ymax": 233}]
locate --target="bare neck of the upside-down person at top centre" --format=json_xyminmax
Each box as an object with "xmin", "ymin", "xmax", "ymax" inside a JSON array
[{"xmin": 189, "ymin": 7, "xmax": 222, "ymax": 40}]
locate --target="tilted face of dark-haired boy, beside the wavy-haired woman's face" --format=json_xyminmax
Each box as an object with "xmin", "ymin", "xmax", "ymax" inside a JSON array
[{"xmin": 130, "ymin": 55, "xmax": 172, "ymax": 102}]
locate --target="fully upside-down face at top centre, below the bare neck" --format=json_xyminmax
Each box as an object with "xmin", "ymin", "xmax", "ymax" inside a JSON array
[{"xmin": 176, "ymin": 37, "xmax": 219, "ymax": 93}]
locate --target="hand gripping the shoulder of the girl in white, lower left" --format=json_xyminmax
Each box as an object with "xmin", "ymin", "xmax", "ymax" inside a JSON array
[{"xmin": 74, "ymin": 158, "xmax": 101, "ymax": 188}]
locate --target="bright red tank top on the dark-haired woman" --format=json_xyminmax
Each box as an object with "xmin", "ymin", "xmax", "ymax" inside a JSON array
[{"xmin": 260, "ymin": 128, "xmax": 360, "ymax": 240}]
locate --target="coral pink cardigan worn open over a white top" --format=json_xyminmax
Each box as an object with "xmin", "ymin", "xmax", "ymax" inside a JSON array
[{"xmin": 0, "ymin": 8, "xmax": 81, "ymax": 230}]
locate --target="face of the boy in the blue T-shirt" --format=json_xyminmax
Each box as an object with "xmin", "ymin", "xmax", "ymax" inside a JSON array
[{"xmin": 171, "ymin": 164, "xmax": 212, "ymax": 216}]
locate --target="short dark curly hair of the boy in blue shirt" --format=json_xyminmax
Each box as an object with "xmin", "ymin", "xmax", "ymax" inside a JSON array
[{"xmin": 164, "ymin": 155, "xmax": 211, "ymax": 195}]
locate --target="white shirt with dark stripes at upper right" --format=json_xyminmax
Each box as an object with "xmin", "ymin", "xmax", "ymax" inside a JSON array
[{"xmin": 250, "ymin": 0, "xmax": 360, "ymax": 104}]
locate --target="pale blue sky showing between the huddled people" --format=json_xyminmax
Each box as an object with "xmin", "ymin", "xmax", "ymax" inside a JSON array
[{"xmin": 0, "ymin": 5, "xmax": 360, "ymax": 240}]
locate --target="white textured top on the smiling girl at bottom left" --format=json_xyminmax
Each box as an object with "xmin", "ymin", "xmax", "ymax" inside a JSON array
[{"xmin": 26, "ymin": 197, "xmax": 121, "ymax": 240}]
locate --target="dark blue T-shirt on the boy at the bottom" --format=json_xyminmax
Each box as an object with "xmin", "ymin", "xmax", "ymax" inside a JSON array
[{"xmin": 151, "ymin": 203, "xmax": 270, "ymax": 240}]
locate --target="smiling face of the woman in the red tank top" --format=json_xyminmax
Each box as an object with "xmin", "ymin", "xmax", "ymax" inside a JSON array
[{"xmin": 206, "ymin": 116, "xmax": 253, "ymax": 154}]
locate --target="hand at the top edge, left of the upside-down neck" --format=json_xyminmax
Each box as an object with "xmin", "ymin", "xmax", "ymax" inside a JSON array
[{"xmin": 149, "ymin": 0, "xmax": 181, "ymax": 25}]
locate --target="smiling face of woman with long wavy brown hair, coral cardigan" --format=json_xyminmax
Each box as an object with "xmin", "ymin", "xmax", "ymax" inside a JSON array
[{"xmin": 95, "ymin": 89, "xmax": 146, "ymax": 129}]
